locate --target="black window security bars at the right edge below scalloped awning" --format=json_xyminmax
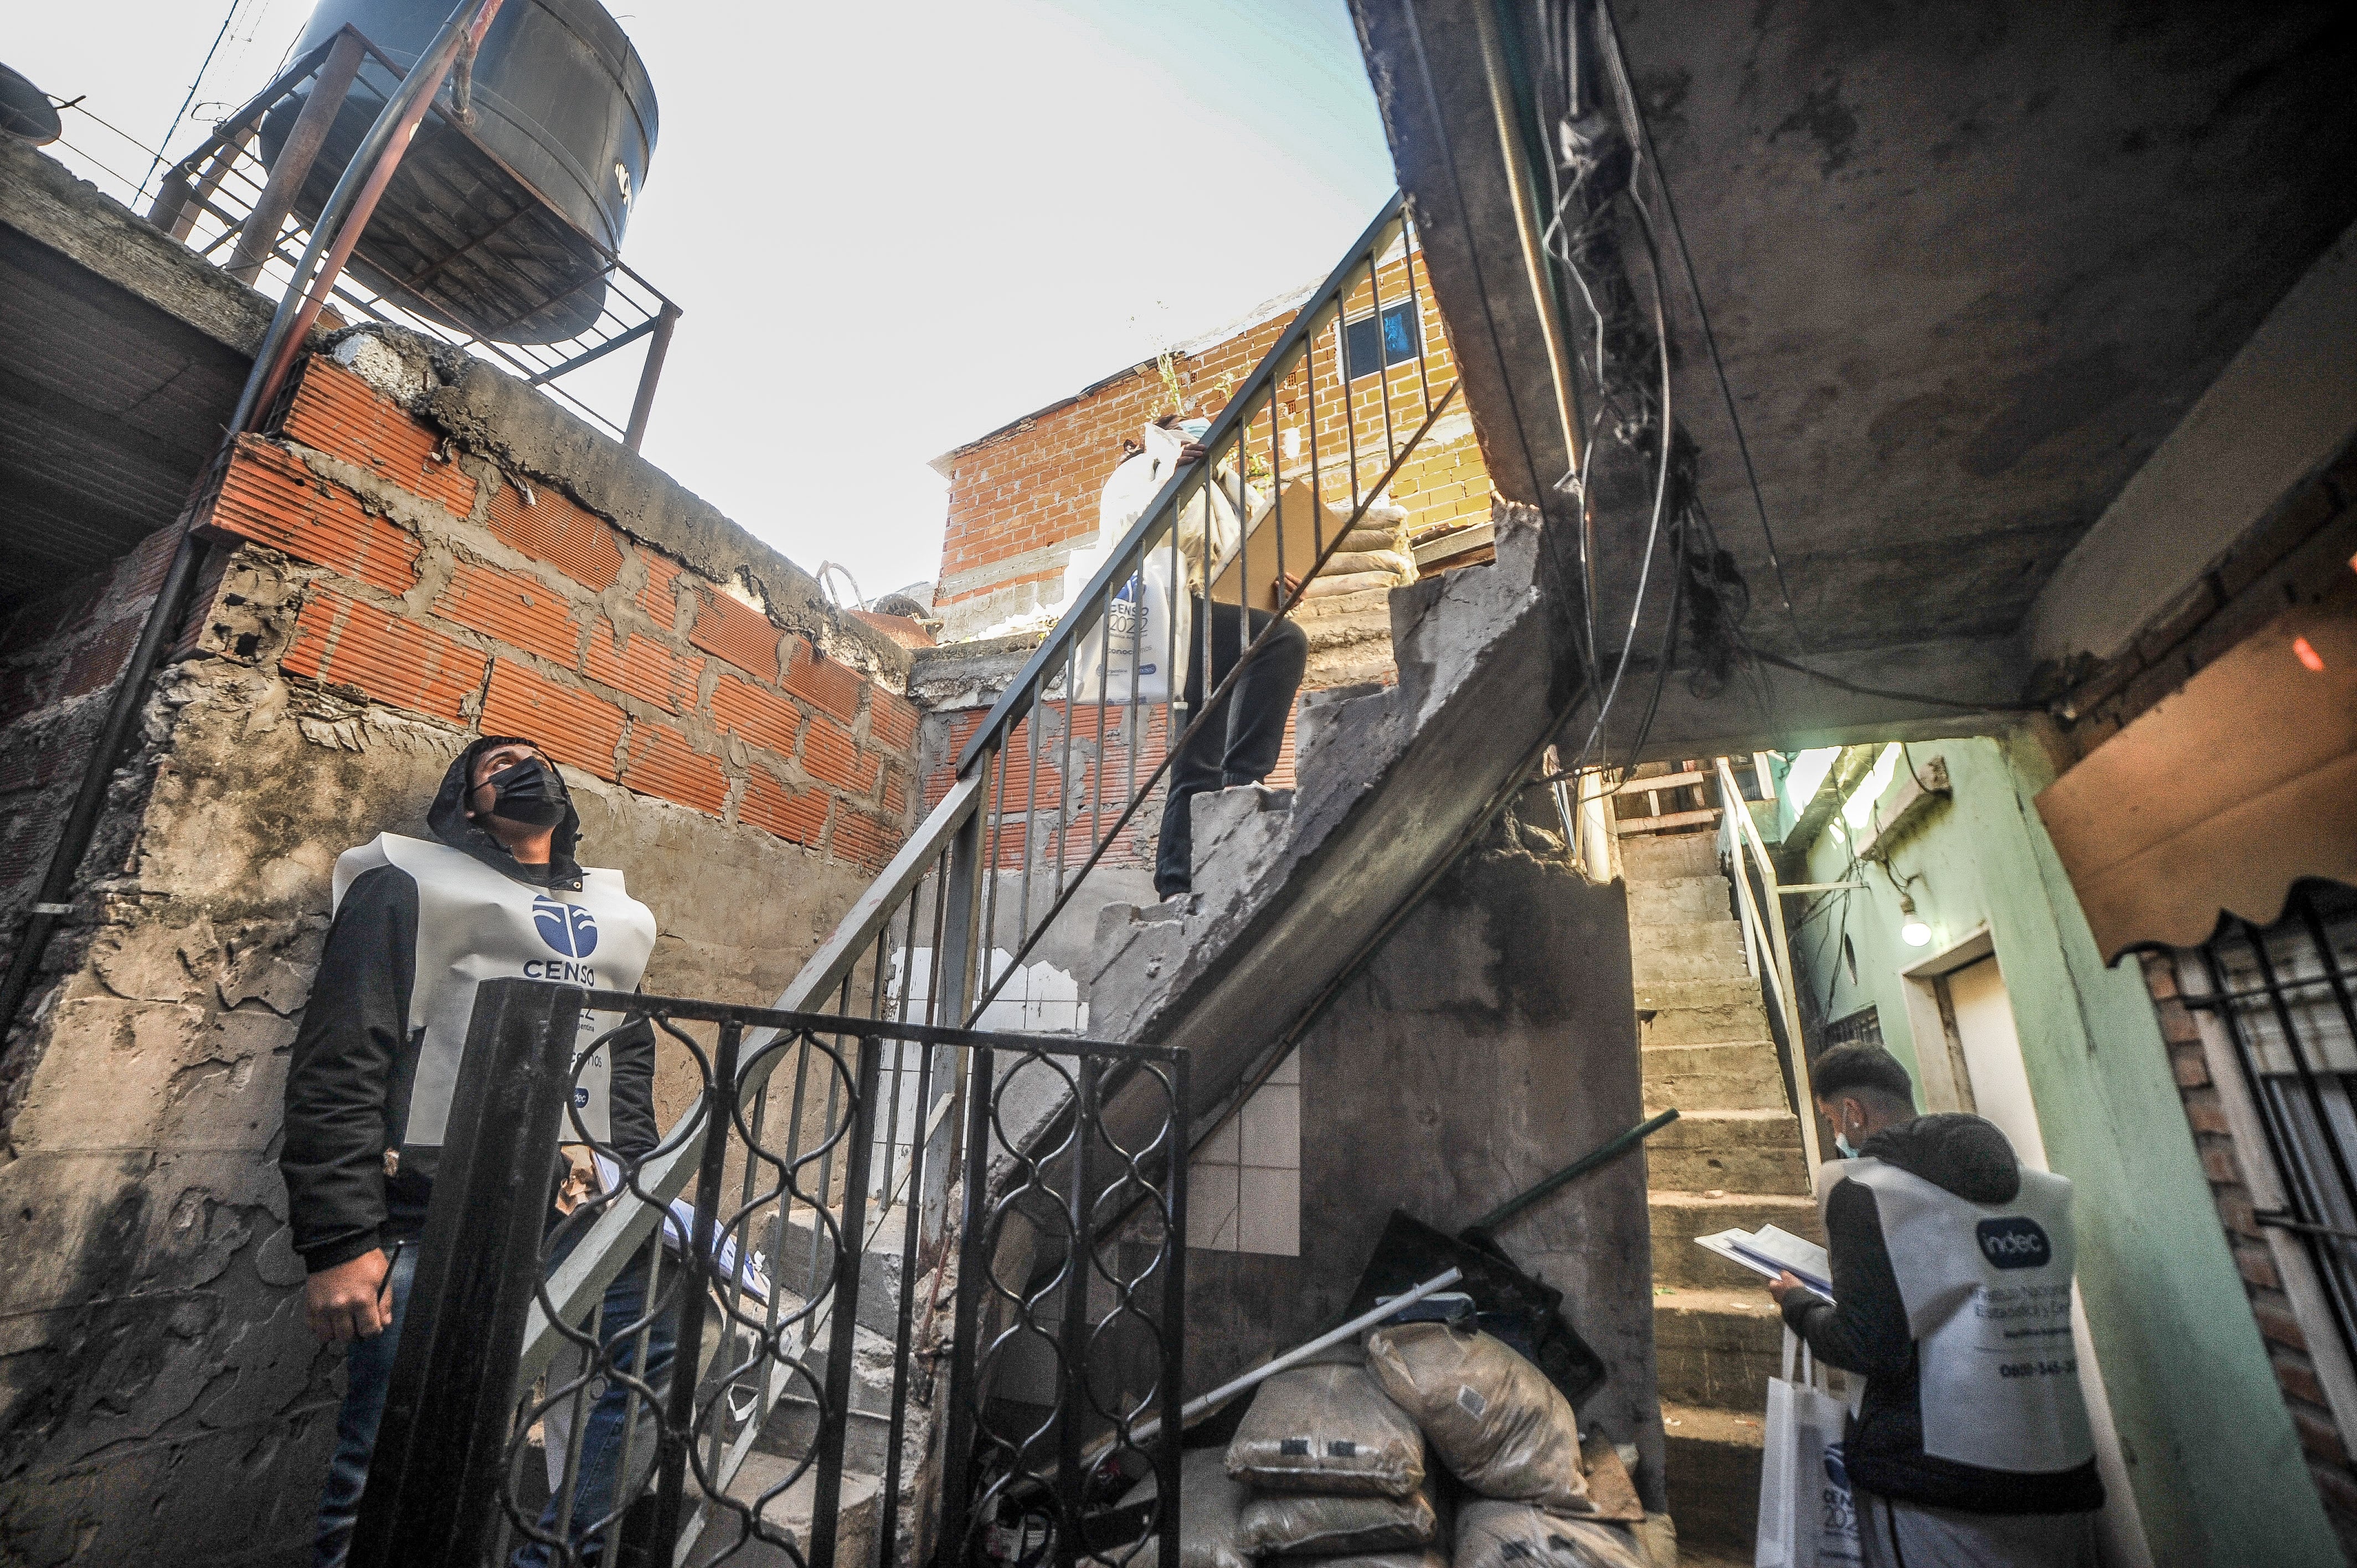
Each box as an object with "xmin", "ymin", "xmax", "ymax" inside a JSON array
[{"xmin": 2178, "ymin": 882, "xmax": 2357, "ymax": 1351}]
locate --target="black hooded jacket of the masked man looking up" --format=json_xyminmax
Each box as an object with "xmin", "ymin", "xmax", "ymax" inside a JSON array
[{"xmin": 278, "ymin": 736, "xmax": 657, "ymax": 1273}]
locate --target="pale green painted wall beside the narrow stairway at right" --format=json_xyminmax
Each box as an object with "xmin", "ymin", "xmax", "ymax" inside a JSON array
[{"xmin": 1787, "ymin": 733, "xmax": 2343, "ymax": 1568}]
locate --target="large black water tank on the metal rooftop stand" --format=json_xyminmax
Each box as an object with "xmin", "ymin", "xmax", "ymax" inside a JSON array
[{"xmin": 261, "ymin": 0, "xmax": 655, "ymax": 342}]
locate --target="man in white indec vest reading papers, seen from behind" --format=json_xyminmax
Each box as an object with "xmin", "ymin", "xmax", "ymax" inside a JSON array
[{"xmin": 1768, "ymin": 1045, "xmax": 2102, "ymax": 1568}]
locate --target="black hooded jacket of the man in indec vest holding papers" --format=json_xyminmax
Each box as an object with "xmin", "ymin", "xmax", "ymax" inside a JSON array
[{"xmin": 1784, "ymin": 1115, "xmax": 2102, "ymax": 1514}]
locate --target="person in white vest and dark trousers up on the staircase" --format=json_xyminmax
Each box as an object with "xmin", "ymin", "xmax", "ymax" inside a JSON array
[{"xmin": 1063, "ymin": 415, "xmax": 1310, "ymax": 899}]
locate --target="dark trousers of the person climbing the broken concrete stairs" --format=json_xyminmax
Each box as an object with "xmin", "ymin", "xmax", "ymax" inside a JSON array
[{"xmin": 1155, "ymin": 599, "xmax": 1310, "ymax": 899}]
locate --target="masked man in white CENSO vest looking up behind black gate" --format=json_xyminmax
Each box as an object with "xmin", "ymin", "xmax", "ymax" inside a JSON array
[{"xmin": 278, "ymin": 736, "xmax": 672, "ymax": 1568}]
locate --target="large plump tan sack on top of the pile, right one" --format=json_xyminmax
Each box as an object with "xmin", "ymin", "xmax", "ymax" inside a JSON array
[{"xmin": 1376, "ymin": 1323, "xmax": 1596, "ymax": 1514}]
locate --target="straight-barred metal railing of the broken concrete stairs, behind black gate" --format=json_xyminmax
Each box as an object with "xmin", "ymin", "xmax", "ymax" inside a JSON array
[{"xmin": 518, "ymin": 195, "xmax": 1457, "ymax": 1540}]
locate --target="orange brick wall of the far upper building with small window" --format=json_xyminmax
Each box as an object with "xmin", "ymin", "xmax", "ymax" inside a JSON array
[{"xmin": 936, "ymin": 245, "xmax": 1490, "ymax": 635}]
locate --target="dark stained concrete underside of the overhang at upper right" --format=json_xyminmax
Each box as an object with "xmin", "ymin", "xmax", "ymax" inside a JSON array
[{"xmin": 1353, "ymin": 0, "xmax": 2357, "ymax": 757}]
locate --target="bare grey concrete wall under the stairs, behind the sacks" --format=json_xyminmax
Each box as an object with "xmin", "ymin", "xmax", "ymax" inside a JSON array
[{"xmin": 1188, "ymin": 854, "xmax": 1664, "ymax": 1509}]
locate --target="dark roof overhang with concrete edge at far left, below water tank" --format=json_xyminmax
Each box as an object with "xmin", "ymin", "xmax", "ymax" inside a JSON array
[{"xmin": 0, "ymin": 137, "xmax": 271, "ymax": 613}]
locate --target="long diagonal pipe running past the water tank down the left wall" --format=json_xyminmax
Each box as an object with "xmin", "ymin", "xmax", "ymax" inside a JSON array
[{"xmin": 0, "ymin": 0, "xmax": 502, "ymax": 1051}]
